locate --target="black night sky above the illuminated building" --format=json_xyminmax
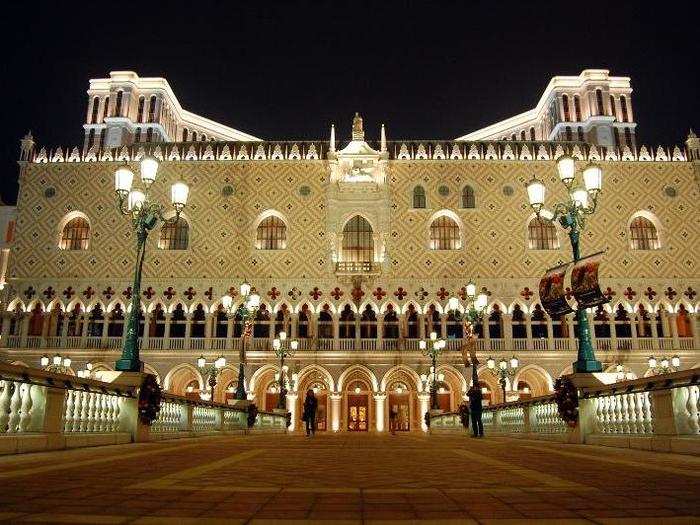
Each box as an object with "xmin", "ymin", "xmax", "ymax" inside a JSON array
[{"xmin": 0, "ymin": 0, "xmax": 700, "ymax": 203}]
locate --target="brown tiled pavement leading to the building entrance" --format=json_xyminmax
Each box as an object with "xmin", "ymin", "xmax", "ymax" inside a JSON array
[{"xmin": 0, "ymin": 434, "xmax": 700, "ymax": 525}]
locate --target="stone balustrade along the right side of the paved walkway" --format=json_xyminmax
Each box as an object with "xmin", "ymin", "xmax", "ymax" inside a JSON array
[{"xmin": 430, "ymin": 368, "xmax": 700, "ymax": 454}]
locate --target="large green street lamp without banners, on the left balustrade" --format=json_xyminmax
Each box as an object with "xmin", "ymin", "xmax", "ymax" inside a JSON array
[{"xmin": 114, "ymin": 157, "xmax": 190, "ymax": 372}]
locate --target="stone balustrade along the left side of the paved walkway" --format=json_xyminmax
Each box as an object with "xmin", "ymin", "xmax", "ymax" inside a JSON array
[{"xmin": 0, "ymin": 363, "xmax": 286, "ymax": 454}]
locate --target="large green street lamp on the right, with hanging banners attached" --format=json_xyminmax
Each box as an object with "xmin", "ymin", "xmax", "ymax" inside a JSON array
[{"xmin": 527, "ymin": 155, "xmax": 603, "ymax": 372}]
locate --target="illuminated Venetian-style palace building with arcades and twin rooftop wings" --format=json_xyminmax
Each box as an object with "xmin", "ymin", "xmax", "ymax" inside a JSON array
[{"xmin": 0, "ymin": 70, "xmax": 700, "ymax": 431}]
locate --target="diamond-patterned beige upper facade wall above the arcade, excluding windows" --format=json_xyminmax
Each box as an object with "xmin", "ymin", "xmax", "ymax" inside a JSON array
[{"xmin": 9, "ymin": 160, "xmax": 700, "ymax": 310}]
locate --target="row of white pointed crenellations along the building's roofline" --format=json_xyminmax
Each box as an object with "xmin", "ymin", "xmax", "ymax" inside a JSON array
[{"xmin": 28, "ymin": 140, "xmax": 688, "ymax": 164}]
